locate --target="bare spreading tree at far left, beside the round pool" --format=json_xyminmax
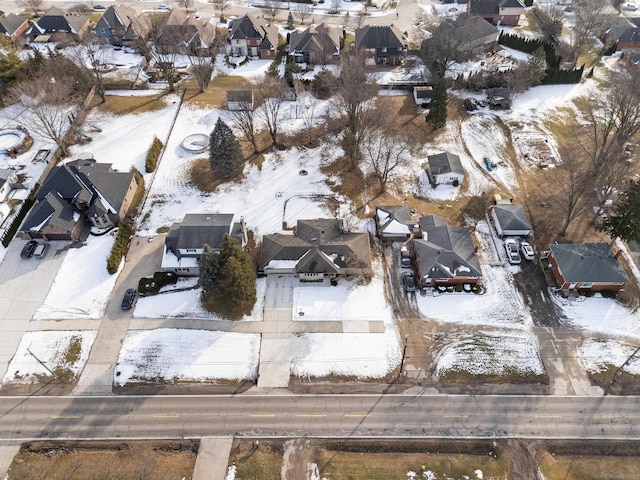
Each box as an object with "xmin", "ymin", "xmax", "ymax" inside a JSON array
[{"xmin": 9, "ymin": 76, "xmax": 79, "ymax": 156}]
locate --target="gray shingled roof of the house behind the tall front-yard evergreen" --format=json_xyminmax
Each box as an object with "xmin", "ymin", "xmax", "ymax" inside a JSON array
[{"xmin": 165, "ymin": 213, "xmax": 233, "ymax": 253}]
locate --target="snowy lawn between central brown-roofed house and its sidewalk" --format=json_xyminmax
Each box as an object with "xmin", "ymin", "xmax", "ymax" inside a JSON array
[{"xmin": 292, "ymin": 277, "xmax": 392, "ymax": 323}]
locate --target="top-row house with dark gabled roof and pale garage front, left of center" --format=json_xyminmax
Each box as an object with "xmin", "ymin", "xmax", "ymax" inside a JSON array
[{"xmin": 227, "ymin": 14, "xmax": 278, "ymax": 60}]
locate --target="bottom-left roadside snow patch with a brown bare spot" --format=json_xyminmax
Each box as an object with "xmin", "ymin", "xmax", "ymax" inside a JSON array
[{"xmin": 2, "ymin": 330, "xmax": 98, "ymax": 383}]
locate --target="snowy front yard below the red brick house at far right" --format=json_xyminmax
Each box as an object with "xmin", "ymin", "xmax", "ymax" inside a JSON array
[{"xmin": 551, "ymin": 293, "xmax": 640, "ymax": 339}]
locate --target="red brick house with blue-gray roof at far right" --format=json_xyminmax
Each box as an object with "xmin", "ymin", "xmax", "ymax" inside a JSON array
[{"xmin": 547, "ymin": 243, "xmax": 629, "ymax": 291}]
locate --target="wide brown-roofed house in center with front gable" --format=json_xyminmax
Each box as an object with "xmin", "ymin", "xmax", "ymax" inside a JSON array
[{"xmin": 260, "ymin": 218, "xmax": 371, "ymax": 281}]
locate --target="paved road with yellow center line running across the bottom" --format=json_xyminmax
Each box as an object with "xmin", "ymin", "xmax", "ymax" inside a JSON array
[{"xmin": 0, "ymin": 394, "xmax": 640, "ymax": 441}]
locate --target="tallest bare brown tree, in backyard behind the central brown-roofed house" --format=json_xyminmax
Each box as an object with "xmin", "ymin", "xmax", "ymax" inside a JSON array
[{"xmin": 332, "ymin": 50, "xmax": 378, "ymax": 170}]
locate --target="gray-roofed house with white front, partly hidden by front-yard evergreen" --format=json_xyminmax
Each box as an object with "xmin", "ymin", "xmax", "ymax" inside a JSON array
[{"xmin": 161, "ymin": 213, "xmax": 247, "ymax": 276}]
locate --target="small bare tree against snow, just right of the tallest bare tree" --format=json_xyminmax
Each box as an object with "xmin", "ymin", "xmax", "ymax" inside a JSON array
[{"xmin": 362, "ymin": 129, "xmax": 411, "ymax": 194}]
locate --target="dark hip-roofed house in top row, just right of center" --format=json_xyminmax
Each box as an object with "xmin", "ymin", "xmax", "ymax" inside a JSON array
[{"xmin": 356, "ymin": 25, "xmax": 406, "ymax": 65}]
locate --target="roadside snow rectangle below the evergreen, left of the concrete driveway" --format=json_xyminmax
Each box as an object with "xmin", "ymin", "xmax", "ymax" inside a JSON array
[{"xmin": 114, "ymin": 328, "xmax": 260, "ymax": 386}]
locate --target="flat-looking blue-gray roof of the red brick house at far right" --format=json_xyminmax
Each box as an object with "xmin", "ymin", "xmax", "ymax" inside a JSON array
[{"xmin": 549, "ymin": 243, "xmax": 629, "ymax": 283}]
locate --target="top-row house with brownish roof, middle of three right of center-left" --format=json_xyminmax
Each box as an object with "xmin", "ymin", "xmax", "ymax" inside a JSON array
[{"xmin": 289, "ymin": 23, "xmax": 343, "ymax": 65}]
